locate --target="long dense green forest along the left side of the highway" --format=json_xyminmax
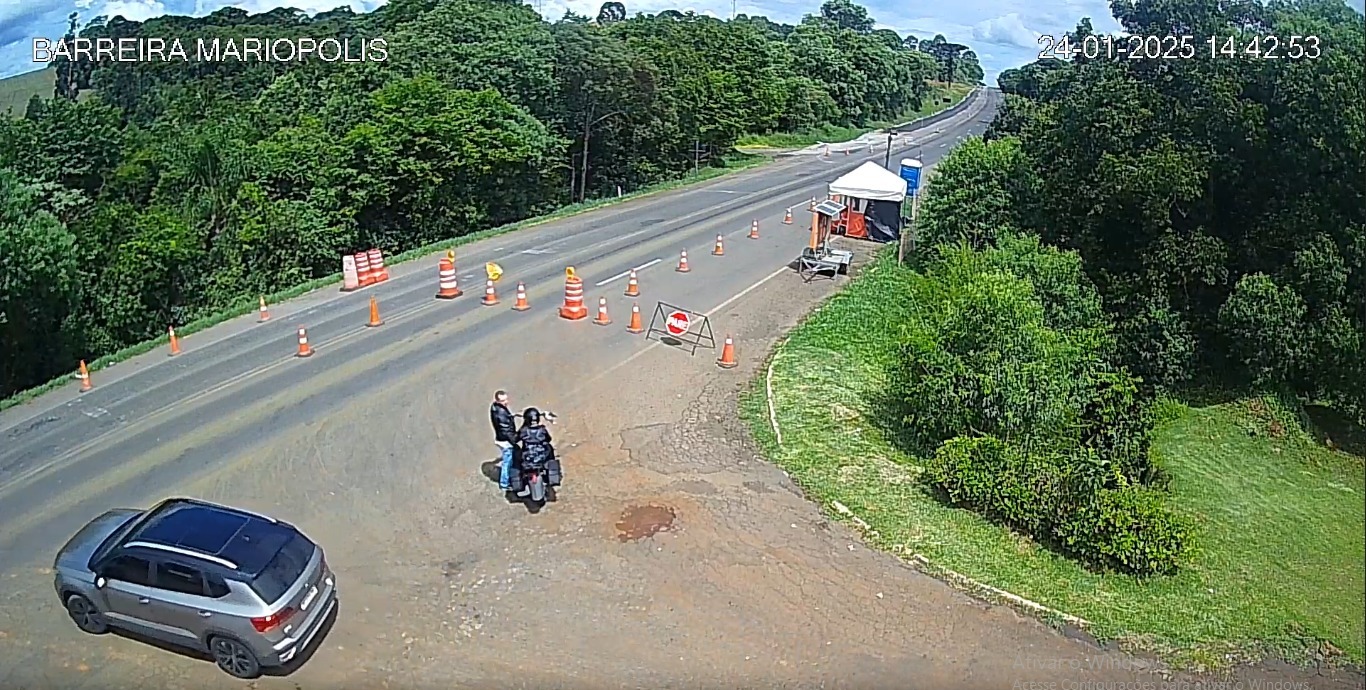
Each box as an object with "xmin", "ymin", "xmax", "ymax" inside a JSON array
[{"xmin": 0, "ymin": 0, "xmax": 982, "ymax": 398}]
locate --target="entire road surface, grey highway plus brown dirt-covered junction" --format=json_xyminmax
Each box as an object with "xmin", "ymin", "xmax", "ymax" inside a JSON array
[{"xmin": 0, "ymin": 87, "xmax": 1349, "ymax": 689}]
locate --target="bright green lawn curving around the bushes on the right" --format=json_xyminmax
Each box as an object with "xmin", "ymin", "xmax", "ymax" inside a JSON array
[{"xmin": 742, "ymin": 251, "xmax": 1366, "ymax": 668}]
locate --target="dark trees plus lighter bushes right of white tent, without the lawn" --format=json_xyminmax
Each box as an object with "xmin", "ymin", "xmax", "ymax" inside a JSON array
[{"xmin": 888, "ymin": 0, "xmax": 1366, "ymax": 574}]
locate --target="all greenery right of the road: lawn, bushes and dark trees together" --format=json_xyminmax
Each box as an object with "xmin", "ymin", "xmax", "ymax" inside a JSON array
[{"xmin": 743, "ymin": 0, "xmax": 1366, "ymax": 667}]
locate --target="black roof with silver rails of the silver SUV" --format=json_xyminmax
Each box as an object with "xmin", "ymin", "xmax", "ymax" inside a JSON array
[{"xmin": 123, "ymin": 499, "xmax": 302, "ymax": 577}]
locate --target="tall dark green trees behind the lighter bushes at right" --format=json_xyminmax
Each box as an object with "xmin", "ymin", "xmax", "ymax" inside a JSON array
[{"xmin": 977, "ymin": 0, "xmax": 1366, "ymax": 417}]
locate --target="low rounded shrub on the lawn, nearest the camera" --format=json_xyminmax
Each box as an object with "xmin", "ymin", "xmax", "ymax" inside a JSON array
[{"xmin": 1056, "ymin": 485, "xmax": 1193, "ymax": 575}]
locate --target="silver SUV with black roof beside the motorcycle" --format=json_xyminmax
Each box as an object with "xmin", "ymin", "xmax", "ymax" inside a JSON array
[{"xmin": 53, "ymin": 499, "xmax": 337, "ymax": 679}]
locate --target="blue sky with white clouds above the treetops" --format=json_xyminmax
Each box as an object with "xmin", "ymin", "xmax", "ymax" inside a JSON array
[{"xmin": 0, "ymin": 0, "xmax": 1366, "ymax": 85}]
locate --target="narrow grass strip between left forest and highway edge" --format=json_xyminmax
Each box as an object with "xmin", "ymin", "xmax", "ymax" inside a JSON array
[{"xmin": 0, "ymin": 153, "xmax": 770, "ymax": 410}]
